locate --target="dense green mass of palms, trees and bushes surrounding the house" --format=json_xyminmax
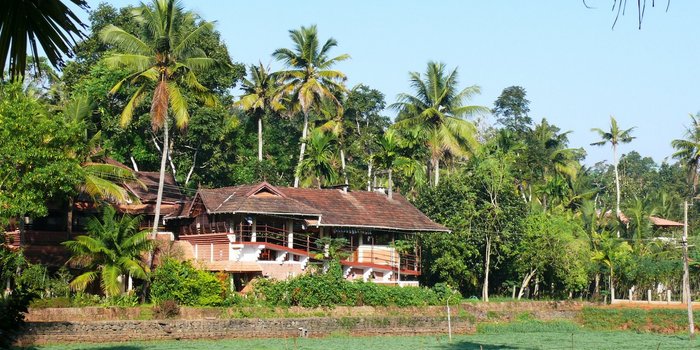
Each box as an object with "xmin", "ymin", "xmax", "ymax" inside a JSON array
[{"xmin": 0, "ymin": 0, "xmax": 700, "ymax": 318}]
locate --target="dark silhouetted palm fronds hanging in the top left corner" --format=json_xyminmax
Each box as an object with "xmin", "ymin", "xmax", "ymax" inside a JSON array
[{"xmin": 0, "ymin": 0, "xmax": 87, "ymax": 80}]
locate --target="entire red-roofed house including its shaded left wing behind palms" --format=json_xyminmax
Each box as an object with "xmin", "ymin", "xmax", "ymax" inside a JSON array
[{"xmin": 8, "ymin": 167, "xmax": 449, "ymax": 289}]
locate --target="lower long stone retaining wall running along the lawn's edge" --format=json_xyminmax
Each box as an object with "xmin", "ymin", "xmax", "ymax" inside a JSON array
[{"xmin": 17, "ymin": 316, "xmax": 474, "ymax": 346}]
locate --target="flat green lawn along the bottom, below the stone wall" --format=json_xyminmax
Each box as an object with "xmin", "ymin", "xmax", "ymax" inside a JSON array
[{"xmin": 28, "ymin": 331, "xmax": 700, "ymax": 350}]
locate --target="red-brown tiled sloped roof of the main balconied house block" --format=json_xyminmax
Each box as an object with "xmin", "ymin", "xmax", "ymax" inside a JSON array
[{"xmin": 197, "ymin": 183, "xmax": 442, "ymax": 232}]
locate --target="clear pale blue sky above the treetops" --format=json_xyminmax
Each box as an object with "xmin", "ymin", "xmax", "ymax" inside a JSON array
[{"xmin": 83, "ymin": 0, "xmax": 700, "ymax": 165}]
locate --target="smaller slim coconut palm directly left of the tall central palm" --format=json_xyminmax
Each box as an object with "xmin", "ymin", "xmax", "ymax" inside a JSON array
[{"xmin": 234, "ymin": 62, "xmax": 284, "ymax": 161}]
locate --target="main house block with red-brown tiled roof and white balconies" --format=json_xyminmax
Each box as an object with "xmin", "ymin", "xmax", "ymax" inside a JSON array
[{"xmin": 166, "ymin": 182, "xmax": 449, "ymax": 288}]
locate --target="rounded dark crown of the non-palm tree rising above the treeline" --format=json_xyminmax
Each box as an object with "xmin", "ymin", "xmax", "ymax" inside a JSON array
[{"xmin": 491, "ymin": 86, "xmax": 532, "ymax": 133}]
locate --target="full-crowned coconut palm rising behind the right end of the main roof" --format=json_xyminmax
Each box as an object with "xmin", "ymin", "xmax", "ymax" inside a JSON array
[{"xmin": 390, "ymin": 62, "xmax": 489, "ymax": 186}]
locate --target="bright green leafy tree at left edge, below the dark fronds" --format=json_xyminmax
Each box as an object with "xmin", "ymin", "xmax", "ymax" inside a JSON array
[{"xmin": 0, "ymin": 84, "xmax": 82, "ymax": 224}]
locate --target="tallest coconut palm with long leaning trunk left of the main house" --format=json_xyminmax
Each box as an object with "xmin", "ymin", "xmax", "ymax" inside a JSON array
[{"xmin": 100, "ymin": 0, "xmax": 217, "ymax": 238}]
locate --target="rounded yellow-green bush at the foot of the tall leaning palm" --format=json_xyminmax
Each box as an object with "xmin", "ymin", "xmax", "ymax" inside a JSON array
[{"xmin": 151, "ymin": 259, "xmax": 226, "ymax": 306}]
